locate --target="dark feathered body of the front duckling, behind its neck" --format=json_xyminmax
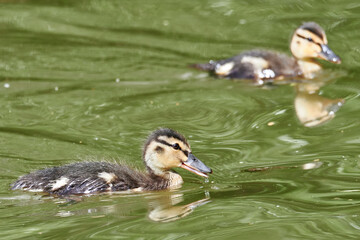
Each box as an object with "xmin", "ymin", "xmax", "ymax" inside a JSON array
[{"xmin": 12, "ymin": 162, "xmax": 147, "ymax": 195}]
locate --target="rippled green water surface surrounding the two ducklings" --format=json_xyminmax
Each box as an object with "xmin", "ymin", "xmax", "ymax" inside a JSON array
[{"xmin": 0, "ymin": 0, "xmax": 360, "ymax": 240}]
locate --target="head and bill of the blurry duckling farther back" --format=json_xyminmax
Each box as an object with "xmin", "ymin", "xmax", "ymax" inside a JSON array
[{"xmin": 290, "ymin": 22, "xmax": 341, "ymax": 64}]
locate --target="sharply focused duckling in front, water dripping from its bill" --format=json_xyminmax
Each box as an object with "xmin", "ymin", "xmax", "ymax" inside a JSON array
[{"xmin": 12, "ymin": 128, "xmax": 212, "ymax": 196}]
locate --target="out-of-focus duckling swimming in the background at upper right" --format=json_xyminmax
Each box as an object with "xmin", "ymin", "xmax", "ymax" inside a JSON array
[{"xmin": 191, "ymin": 22, "xmax": 341, "ymax": 84}]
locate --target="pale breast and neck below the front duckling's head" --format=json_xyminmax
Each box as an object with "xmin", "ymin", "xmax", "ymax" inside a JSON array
[{"xmin": 145, "ymin": 171, "xmax": 183, "ymax": 190}]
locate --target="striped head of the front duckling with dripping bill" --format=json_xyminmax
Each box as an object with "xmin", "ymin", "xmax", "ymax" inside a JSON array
[{"xmin": 143, "ymin": 128, "xmax": 212, "ymax": 177}]
